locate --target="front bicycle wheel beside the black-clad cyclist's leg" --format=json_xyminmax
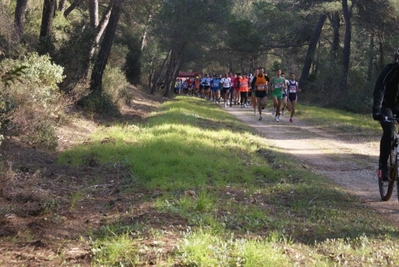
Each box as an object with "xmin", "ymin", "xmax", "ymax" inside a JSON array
[{"xmin": 378, "ymin": 147, "xmax": 399, "ymax": 201}]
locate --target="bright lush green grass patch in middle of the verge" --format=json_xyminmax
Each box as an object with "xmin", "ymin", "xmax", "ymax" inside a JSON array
[{"xmin": 59, "ymin": 97, "xmax": 268, "ymax": 190}]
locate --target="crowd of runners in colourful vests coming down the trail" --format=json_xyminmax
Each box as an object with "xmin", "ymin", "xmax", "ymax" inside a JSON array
[{"xmin": 176, "ymin": 67, "xmax": 301, "ymax": 123}]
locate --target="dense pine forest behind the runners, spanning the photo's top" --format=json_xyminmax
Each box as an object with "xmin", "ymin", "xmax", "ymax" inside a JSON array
[{"xmin": 0, "ymin": 0, "xmax": 399, "ymax": 111}]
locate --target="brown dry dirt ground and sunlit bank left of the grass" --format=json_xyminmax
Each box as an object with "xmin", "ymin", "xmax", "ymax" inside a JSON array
[{"xmin": 0, "ymin": 88, "xmax": 167, "ymax": 267}]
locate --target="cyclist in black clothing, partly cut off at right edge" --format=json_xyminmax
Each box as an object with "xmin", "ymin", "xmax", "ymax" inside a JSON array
[{"xmin": 373, "ymin": 49, "xmax": 399, "ymax": 181}]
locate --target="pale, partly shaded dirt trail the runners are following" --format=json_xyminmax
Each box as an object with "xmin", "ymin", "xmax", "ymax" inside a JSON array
[{"xmin": 225, "ymin": 106, "xmax": 399, "ymax": 226}]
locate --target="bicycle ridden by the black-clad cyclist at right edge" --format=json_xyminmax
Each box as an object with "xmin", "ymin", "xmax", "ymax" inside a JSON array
[{"xmin": 378, "ymin": 116, "xmax": 399, "ymax": 201}]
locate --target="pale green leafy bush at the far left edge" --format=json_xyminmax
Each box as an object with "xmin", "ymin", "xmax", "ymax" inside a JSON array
[{"xmin": 0, "ymin": 53, "xmax": 64, "ymax": 149}]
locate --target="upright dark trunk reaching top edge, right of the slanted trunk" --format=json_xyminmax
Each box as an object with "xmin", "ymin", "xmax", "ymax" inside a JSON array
[{"xmin": 339, "ymin": 0, "xmax": 354, "ymax": 96}]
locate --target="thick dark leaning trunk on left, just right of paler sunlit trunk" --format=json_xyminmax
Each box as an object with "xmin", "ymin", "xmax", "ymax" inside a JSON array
[{"xmin": 90, "ymin": 0, "xmax": 124, "ymax": 94}]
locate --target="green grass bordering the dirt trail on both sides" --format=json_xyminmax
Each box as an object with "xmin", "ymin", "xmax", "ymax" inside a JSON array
[{"xmin": 59, "ymin": 97, "xmax": 399, "ymax": 266}]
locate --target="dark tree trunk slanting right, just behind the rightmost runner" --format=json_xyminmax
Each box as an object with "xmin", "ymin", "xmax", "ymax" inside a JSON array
[{"xmin": 299, "ymin": 14, "xmax": 327, "ymax": 91}]
